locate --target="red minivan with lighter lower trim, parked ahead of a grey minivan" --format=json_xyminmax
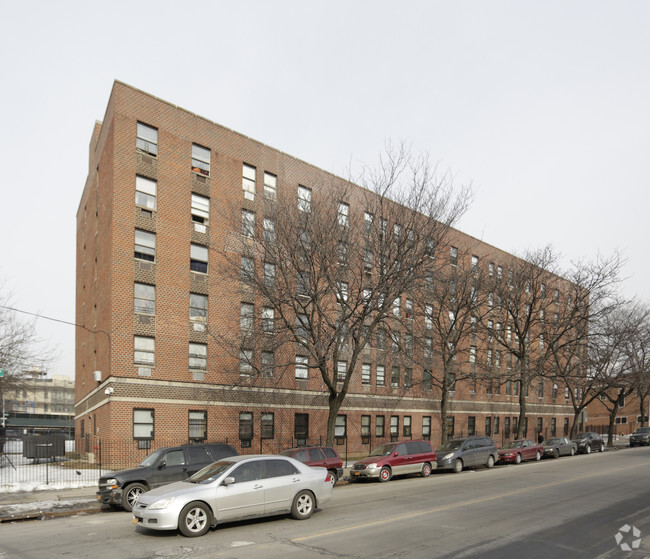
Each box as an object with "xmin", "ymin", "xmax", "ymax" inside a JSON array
[{"xmin": 350, "ymin": 441, "xmax": 436, "ymax": 481}]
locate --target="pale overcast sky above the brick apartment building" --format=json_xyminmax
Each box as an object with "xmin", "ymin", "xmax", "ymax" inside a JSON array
[{"xmin": 0, "ymin": 0, "xmax": 650, "ymax": 376}]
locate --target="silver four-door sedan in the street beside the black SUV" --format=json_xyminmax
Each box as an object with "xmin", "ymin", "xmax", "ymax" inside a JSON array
[{"xmin": 133, "ymin": 455, "xmax": 334, "ymax": 537}]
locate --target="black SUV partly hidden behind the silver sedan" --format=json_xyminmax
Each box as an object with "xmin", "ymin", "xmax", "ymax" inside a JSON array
[{"xmin": 97, "ymin": 443, "xmax": 238, "ymax": 512}]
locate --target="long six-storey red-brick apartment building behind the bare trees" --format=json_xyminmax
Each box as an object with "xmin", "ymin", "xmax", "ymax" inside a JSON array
[{"xmin": 75, "ymin": 82, "xmax": 572, "ymax": 460}]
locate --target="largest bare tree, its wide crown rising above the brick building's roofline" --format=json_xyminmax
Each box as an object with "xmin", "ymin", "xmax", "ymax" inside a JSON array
[{"xmin": 212, "ymin": 146, "xmax": 470, "ymax": 443}]
